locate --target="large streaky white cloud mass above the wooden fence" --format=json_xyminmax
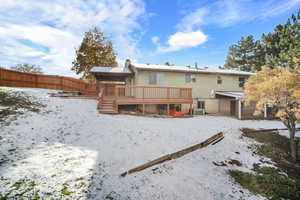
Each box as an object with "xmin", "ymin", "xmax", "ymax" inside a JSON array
[{"xmin": 0, "ymin": 0, "xmax": 145, "ymax": 75}]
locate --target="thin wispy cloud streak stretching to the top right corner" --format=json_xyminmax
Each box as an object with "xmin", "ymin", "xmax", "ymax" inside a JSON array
[{"xmin": 177, "ymin": 0, "xmax": 300, "ymax": 28}]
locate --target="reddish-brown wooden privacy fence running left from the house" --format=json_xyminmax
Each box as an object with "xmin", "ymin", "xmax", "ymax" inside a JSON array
[{"xmin": 0, "ymin": 68, "xmax": 96, "ymax": 95}]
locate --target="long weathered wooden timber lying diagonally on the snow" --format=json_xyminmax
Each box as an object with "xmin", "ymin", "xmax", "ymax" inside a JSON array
[{"xmin": 121, "ymin": 132, "xmax": 224, "ymax": 177}]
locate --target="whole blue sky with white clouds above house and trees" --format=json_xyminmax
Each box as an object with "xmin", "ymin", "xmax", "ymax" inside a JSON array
[{"xmin": 0, "ymin": 0, "xmax": 300, "ymax": 76}]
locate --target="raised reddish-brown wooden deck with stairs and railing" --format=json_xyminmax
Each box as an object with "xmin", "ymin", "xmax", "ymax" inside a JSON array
[{"xmin": 99, "ymin": 86, "xmax": 193, "ymax": 114}]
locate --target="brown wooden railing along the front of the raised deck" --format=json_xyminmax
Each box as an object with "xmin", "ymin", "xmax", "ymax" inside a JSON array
[{"xmin": 115, "ymin": 86, "xmax": 192, "ymax": 99}]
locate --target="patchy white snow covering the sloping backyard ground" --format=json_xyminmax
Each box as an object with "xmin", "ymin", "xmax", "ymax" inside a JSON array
[{"xmin": 0, "ymin": 89, "xmax": 283, "ymax": 200}]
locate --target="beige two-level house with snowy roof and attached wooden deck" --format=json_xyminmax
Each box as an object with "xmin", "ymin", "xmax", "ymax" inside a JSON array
[{"xmin": 91, "ymin": 60, "xmax": 264, "ymax": 119}]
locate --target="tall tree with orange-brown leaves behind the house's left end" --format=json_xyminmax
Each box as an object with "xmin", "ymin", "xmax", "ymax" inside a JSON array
[{"xmin": 72, "ymin": 28, "xmax": 117, "ymax": 80}]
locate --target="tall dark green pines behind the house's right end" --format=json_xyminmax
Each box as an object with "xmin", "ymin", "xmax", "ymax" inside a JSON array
[{"xmin": 224, "ymin": 10, "xmax": 300, "ymax": 72}]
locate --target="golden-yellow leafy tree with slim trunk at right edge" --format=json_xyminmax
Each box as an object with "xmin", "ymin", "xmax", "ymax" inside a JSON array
[{"xmin": 245, "ymin": 58, "xmax": 300, "ymax": 161}]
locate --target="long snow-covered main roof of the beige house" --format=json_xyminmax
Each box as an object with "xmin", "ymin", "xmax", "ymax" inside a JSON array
[{"xmin": 132, "ymin": 63, "xmax": 254, "ymax": 76}]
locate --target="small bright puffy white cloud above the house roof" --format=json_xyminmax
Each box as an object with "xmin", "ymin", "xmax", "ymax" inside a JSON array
[{"xmin": 158, "ymin": 30, "xmax": 207, "ymax": 52}]
